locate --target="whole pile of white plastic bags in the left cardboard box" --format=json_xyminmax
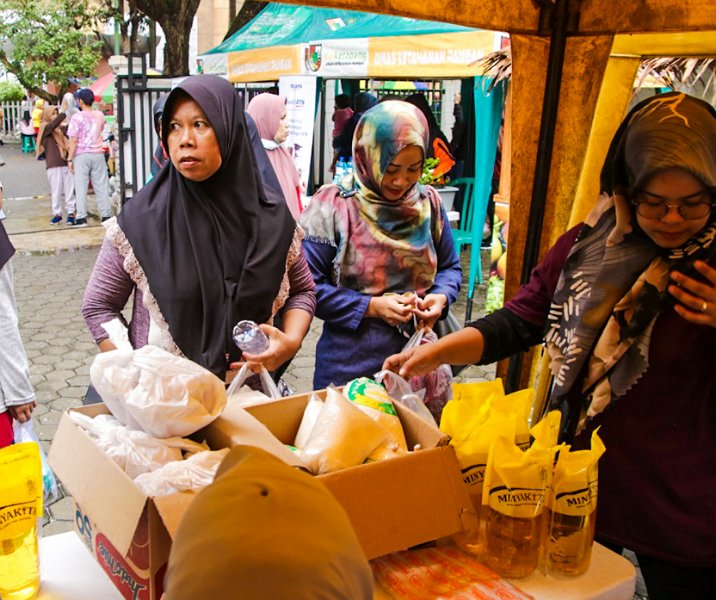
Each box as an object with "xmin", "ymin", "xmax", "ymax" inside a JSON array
[{"xmin": 79, "ymin": 319, "xmax": 228, "ymax": 496}]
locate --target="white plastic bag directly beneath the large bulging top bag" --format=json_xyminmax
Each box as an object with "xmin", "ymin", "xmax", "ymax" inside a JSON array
[{"xmin": 68, "ymin": 412, "xmax": 209, "ymax": 479}]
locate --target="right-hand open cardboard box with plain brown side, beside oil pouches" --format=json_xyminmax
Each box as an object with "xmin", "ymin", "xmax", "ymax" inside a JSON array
[{"xmin": 202, "ymin": 390, "xmax": 475, "ymax": 559}]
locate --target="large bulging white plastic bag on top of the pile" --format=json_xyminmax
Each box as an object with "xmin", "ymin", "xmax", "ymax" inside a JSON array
[{"xmin": 90, "ymin": 319, "xmax": 226, "ymax": 438}]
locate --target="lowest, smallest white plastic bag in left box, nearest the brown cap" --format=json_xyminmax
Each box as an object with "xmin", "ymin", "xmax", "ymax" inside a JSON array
[{"xmin": 134, "ymin": 448, "xmax": 229, "ymax": 496}]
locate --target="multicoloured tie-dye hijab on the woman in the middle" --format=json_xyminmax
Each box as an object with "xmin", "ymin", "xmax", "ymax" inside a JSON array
[{"xmin": 301, "ymin": 100, "xmax": 444, "ymax": 295}]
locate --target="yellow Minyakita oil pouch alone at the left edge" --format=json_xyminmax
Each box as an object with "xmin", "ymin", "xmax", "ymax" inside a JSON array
[{"xmin": 0, "ymin": 442, "xmax": 43, "ymax": 600}]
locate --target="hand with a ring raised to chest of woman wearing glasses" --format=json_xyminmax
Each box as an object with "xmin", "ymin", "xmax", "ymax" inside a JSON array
[{"xmin": 669, "ymin": 260, "xmax": 716, "ymax": 327}]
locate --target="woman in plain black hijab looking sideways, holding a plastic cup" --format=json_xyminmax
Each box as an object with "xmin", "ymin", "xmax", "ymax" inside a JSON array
[{"xmin": 83, "ymin": 75, "xmax": 315, "ymax": 379}]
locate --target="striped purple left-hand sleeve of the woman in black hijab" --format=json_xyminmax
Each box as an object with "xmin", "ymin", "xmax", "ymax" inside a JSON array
[{"xmin": 82, "ymin": 238, "xmax": 134, "ymax": 343}]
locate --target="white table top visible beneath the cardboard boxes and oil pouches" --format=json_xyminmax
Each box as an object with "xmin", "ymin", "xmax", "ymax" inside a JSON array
[{"xmin": 38, "ymin": 531, "xmax": 636, "ymax": 600}]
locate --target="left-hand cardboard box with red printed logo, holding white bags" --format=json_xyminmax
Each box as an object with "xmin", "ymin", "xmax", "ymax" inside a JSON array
[{"xmin": 48, "ymin": 404, "xmax": 294, "ymax": 600}]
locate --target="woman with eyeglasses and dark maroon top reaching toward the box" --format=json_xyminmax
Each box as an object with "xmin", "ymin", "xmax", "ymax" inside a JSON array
[{"xmin": 384, "ymin": 93, "xmax": 716, "ymax": 600}]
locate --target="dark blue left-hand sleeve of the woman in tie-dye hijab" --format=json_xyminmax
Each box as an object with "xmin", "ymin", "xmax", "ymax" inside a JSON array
[{"xmin": 303, "ymin": 240, "xmax": 370, "ymax": 331}]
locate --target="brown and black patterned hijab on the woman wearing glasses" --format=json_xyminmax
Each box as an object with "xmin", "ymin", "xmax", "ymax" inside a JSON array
[{"xmin": 545, "ymin": 92, "xmax": 716, "ymax": 432}]
